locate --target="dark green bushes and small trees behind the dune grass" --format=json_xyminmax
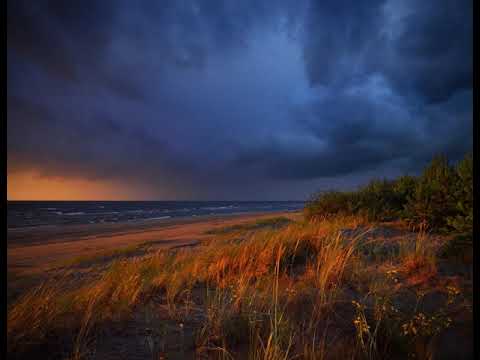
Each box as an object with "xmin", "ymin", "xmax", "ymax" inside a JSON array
[{"xmin": 305, "ymin": 153, "xmax": 473, "ymax": 237}]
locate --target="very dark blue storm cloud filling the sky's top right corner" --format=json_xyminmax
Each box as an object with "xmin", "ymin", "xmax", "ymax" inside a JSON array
[{"xmin": 378, "ymin": 0, "xmax": 473, "ymax": 103}]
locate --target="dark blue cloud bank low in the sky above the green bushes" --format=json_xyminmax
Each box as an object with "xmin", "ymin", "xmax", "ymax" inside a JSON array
[{"xmin": 238, "ymin": 84, "xmax": 472, "ymax": 179}]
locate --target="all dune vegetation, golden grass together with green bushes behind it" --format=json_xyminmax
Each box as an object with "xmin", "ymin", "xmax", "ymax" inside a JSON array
[{"xmin": 7, "ymin": 153, "xmax": 473, "ymax": 360}]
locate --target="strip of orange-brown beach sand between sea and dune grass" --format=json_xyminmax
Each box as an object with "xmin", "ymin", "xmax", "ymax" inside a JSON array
[{"xmin": 7, "ymin": 212, "xmax": 300, "ymax": 275}]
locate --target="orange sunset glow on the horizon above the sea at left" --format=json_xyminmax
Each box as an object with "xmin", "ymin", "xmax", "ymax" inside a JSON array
[{"xmin": 7, "ymin": 172, "xmax": 151, "ymax": 200}]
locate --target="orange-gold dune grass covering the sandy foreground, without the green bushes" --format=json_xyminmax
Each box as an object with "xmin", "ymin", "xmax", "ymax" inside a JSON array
[{"xmin": 7, "ymin": 212, "xmax": 472, "ymax": 360}]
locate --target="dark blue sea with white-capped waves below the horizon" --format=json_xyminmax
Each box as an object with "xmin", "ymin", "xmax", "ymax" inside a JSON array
[{"xmin": 7, "ymin": 201, "xmax": 305, "ymax": 229}]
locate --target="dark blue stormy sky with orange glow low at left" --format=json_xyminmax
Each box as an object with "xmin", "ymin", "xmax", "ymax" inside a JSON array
[{"xmin": 7, "ymin": 0, "xmax": 472, "ymax": 200}]
